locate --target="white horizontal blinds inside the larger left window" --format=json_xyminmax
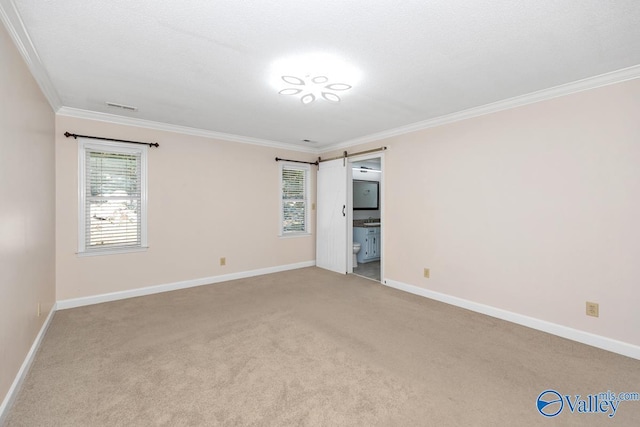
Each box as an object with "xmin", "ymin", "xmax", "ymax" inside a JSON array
[{"xmin": 85, "ymin": 149, "xmax": 142, "ymax": 251}]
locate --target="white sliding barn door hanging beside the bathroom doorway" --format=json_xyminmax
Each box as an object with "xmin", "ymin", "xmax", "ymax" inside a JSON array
[{"xmin": 316, "ymin": 159, "xmax": 349, "ymax": 274}]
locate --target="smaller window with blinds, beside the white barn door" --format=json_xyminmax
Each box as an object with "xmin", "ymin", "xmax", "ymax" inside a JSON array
[{"xmin": 280, "ymin": 163, "xmax": 309, "ymax": 236}]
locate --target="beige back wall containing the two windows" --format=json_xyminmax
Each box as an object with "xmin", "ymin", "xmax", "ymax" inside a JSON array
[{"xmin": 56, "ymin": 115, "xmax": 315, "ymax": 301}]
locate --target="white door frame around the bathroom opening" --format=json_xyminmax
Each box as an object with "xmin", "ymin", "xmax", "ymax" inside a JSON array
[{"xmin": 347, "ymin": 152, "xmax": 386, "ymax": 283}]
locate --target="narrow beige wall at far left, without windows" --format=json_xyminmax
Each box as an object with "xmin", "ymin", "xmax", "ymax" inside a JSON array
[{"xmin": 0, "ymin": 25, "xmax": 55, "ymax": 408}]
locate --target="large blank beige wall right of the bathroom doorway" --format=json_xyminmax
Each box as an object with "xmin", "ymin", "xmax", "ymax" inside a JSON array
[{"xmin": 322, "ymin": 79, "xmax": 640, "ymax": 345}]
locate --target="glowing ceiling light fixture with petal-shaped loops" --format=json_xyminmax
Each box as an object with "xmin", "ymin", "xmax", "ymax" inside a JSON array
[{"xmin": 271, "ymin": 54, "xmax": 360, "ymax": 105}]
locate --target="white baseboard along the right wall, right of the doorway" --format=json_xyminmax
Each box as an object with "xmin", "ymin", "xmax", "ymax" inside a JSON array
[{"xmin": 382, "ymin": 279, "xmax": 640, "ymax": 360}]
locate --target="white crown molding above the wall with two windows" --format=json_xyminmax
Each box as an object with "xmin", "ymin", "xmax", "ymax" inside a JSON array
[{"xmin": 56, "ymin": 107, "xmax": 318, "ymax": 154}]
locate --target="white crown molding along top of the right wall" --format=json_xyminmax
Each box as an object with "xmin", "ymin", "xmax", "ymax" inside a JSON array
[{"xmin": 322, "ymin": 65, "xmax": 640, "ymax": 153}]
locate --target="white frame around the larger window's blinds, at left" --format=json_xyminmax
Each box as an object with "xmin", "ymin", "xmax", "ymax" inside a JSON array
[{"xmin": 77, "ymin": 138, "xmax": 148, "ymax": 256}]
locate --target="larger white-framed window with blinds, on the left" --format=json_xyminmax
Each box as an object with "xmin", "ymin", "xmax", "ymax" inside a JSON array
[{"xmin": 78, "ymin": 141, "xmax": 147, "ymax": 254}]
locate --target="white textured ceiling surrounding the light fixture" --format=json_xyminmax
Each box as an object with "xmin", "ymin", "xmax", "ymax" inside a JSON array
[{"xmin": 0, "ymin": 0, "xmax": 640, "ymax": 151}]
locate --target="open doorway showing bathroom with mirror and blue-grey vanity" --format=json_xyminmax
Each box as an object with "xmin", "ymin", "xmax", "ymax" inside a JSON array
[{"xmin": 348, "ymin": 154, "xmax": 384, "ymax": 282}]
